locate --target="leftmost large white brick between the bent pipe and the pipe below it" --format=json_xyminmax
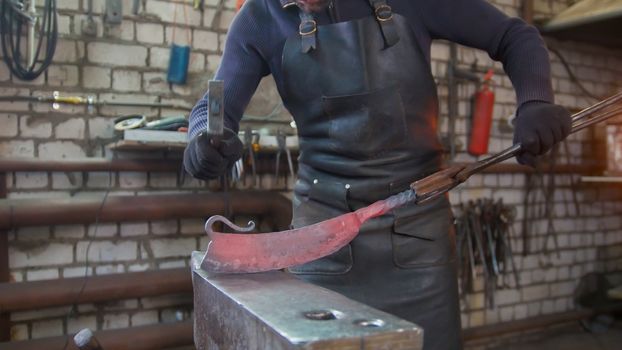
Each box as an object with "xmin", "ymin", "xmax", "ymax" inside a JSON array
[{"xmin": 9, "ymin": 243, "xmax": 73, "ymax": 268}]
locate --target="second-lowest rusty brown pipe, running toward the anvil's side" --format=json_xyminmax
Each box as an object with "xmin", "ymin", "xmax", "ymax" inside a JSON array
[{"xmin": 0, "ymin": 268, "xmax": 192, "ymax": 312}]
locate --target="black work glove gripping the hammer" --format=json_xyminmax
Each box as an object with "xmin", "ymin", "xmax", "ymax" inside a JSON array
[{"xmin": 184, "ymin": 128, "xmax": 244, "ymax": 180}]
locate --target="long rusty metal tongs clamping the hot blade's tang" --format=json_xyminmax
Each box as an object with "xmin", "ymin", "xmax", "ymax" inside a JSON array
[{"xmin": 410, "ymin": 92, "xmax": 622, "ymax": 203}]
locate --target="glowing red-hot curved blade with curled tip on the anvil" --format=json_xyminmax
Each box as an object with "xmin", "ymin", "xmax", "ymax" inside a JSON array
[{"xmin": 201, "ymin": 190, "xmax": 416, "ymax": 273}]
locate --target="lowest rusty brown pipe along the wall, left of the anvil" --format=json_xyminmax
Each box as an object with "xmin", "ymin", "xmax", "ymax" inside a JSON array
[{"xmin": 0, "ymin": 320, "xmax": 193, "ymax": 350}]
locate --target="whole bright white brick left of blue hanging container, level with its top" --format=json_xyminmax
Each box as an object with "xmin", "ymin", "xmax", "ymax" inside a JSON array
[{"xmin": 87, "ymin": 42, "xmax": 147, "ymax": 67}]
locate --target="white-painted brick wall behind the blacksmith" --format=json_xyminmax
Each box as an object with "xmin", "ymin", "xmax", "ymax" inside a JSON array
[{"xmin": 0, "ymin": 0, "xmax": 622, "ymax": 339}]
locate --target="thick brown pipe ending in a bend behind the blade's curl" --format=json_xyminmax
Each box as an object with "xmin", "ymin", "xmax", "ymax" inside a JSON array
[{"xmin": 0, "ymin": 191, "xmax": 292, "ymax": 230}]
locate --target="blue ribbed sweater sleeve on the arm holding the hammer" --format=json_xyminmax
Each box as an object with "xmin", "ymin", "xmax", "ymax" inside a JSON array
[{"xmin": 188, "ymin": 0, "xmax": 270, "ymax": 137}]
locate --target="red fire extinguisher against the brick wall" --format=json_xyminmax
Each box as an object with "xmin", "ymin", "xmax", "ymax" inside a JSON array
[{"xmin": 468, "ymin": 69, "xmax": 495, "ymax": 156}]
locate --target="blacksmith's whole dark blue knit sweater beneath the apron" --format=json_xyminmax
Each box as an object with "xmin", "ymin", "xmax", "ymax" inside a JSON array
[{"xmin": 189, "ymin": 0, "xmax": 553, "ymax": 137}]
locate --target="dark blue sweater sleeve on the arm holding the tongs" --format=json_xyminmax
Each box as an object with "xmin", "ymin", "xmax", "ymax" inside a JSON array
[{"xmin": 417, "ymin": 0, "xmax": 553, "ymax": 106}]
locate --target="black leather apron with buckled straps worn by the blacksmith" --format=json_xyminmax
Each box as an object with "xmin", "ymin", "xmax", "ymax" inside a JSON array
[{"xmin": 281, "ymin": 0, "xmax": 461, "ymax": 350}]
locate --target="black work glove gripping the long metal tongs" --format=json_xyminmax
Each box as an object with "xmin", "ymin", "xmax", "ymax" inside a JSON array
[{"xmin": 514, "ymin": 101, "xmax": 572, "ymax": 167}]
